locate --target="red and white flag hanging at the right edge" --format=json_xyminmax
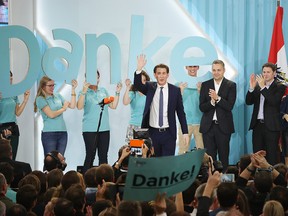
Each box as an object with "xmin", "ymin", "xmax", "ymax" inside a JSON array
[{"xmin": 268, "ymin": 6, "xmax": 288, "ymax": 79}]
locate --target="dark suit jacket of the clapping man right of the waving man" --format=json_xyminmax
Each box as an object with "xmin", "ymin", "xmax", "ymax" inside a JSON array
[{"xmin": 199, "ymin": 78, "xmax": 236, "ymax": 134}]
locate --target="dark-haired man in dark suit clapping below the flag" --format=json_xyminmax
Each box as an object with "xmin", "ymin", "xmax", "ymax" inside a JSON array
[{"xmin": 246, "ymin": 62, "xmax": 285, "ymax": 165}]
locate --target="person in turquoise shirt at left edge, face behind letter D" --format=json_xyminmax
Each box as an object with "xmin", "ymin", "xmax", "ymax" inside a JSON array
[{"xmin": 0, "ymin": 71, "xmax": 30, "ymax": 160}]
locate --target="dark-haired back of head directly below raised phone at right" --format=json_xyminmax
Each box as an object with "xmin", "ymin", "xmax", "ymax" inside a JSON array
[{"xmin": 217, "ymin": 182, "xmax": 238, "ymax": 210}]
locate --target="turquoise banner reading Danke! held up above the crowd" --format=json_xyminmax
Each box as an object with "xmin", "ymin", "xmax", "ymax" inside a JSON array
[{"xmin": 124, "ymin": 149, "xmax": 205, "ymax": 201}]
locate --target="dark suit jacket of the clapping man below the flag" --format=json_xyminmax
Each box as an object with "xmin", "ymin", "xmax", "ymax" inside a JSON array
[{"xmin": 246, "ymin": 81, "xmax": 285, "ymax": 131}]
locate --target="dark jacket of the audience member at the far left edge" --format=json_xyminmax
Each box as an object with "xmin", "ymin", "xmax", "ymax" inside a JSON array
[{"xmin": 0, "ymin": 158, "xmax": 32, "ymax": 188}]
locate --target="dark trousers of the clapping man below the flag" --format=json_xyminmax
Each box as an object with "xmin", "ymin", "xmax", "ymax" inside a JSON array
[{"xmin": 252, "ymin": 122, "xmax": 280, "ymax": 165}]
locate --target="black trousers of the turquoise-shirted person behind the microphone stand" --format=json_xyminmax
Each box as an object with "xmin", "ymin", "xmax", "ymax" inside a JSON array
[{"xmin": 83, "ymin": 131, "xmax": 110, "ymax": 173}]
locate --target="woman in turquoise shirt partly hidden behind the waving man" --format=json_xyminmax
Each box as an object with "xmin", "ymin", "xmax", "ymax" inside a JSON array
[{"xmin": 123, "ymin": 72, "xmax": 150, "ymax": 142}]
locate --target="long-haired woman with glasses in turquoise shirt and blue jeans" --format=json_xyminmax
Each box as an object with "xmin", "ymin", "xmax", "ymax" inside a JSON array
[{"xmin": 34, "ymin": 76, "xmax": 77, "ymax": 155}]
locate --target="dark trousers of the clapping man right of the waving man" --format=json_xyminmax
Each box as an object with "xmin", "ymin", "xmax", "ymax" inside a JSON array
[{"xmin": 202, "ymin": 123, "xmax": 231, "ymax": 171}]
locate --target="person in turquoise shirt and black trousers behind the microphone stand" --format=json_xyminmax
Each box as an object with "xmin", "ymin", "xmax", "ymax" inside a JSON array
[{"xmin": 77, "ymin": 71, "xmax": 122, "ymax": 173}]
